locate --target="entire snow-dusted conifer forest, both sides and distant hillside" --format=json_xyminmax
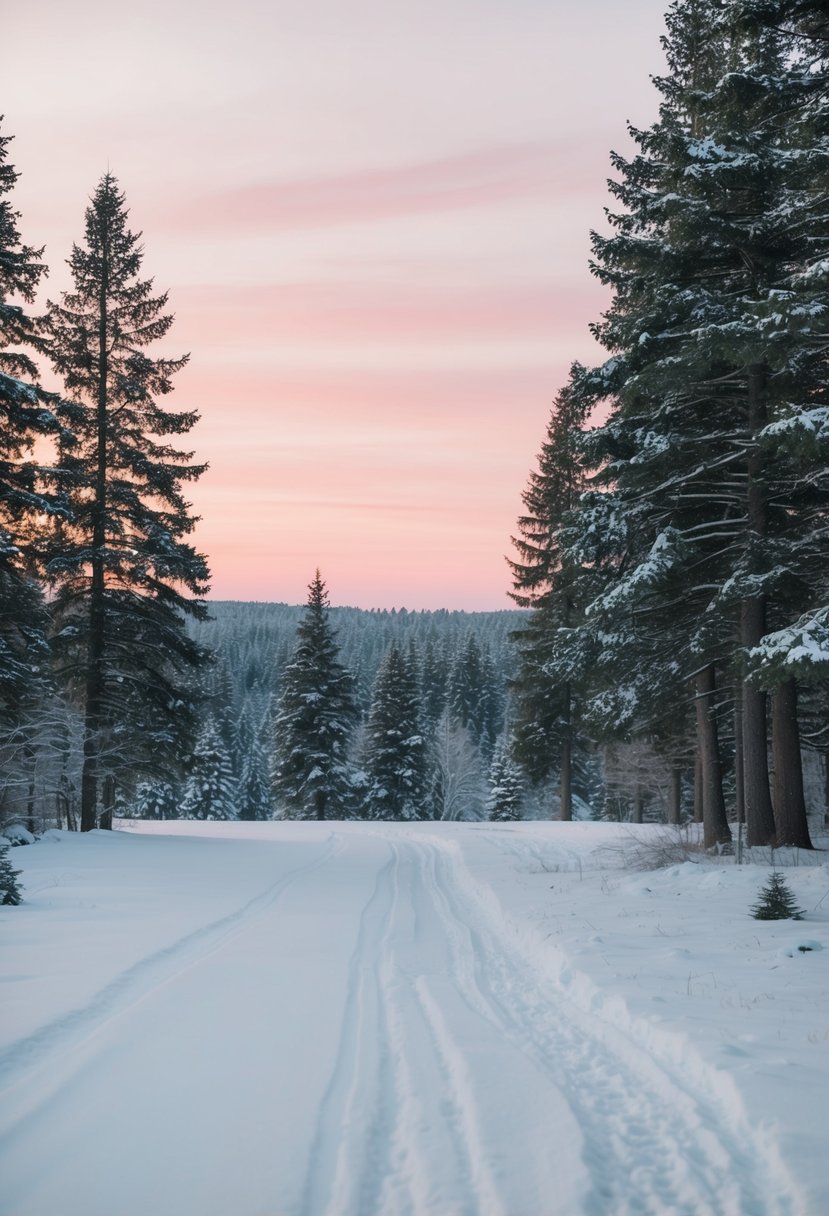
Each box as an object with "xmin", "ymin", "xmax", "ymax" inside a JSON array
[{"xmin": 0, "ymin": 0, "xmax": 829, "ymax": 850}]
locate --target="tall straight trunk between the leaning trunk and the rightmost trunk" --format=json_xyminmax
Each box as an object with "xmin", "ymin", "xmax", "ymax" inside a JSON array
[{"xmin": 740, "ymin": 364, "xmax": 774, "ymax": 845}]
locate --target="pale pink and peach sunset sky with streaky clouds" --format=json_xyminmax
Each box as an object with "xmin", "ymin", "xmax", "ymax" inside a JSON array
[{"xmin": 0, "ymin": 0, "xmax": 664, "ymax": 609}]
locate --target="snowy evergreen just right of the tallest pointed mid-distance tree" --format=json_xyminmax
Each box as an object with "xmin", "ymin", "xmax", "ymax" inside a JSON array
[{"xmin": 363, "ymin": 644, "xmax": 430, "ymax": 820}]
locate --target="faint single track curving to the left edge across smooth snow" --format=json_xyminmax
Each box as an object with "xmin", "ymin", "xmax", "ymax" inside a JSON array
[{"xmin": 0, "ymin": 833, "xmax": 342, "ymax": 1118}]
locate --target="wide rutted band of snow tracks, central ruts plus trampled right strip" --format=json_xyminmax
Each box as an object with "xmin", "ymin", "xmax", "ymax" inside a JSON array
[{"xmin": 303, "ymin": 838, "xmax": 797, "ymax": 1216}]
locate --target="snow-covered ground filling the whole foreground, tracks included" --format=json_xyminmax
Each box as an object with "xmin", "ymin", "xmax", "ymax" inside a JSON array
[{"xmin": 0, "ymin": 822, "xmax": 829, "ymax": 1216}]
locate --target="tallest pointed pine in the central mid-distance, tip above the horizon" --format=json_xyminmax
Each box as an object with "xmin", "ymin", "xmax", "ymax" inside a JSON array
[{"xmin": 272, "ymin": 570, "xmax": 356, "ymax": 820}]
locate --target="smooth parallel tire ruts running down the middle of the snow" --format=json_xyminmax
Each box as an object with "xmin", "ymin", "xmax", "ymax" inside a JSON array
[{"xmin": 300, "ymin": 838, "xmax": 512, "ymax": 1216}]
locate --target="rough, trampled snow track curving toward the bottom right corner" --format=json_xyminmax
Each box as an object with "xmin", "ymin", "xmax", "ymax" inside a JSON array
[{"xmin": 417, "ymin": 837, "xmax": 800, "ymax": 1216}]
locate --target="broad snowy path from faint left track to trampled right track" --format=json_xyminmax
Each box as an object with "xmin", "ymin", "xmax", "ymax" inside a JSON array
[{"xmin": 0, "ymin": 826, "xmax": 799, "ymax": 1216}]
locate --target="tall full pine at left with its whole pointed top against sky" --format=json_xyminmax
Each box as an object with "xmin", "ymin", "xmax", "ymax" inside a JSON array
[{"xmin": 47, "ymin": 173, "xmax": 208, "ymax": 831}]
